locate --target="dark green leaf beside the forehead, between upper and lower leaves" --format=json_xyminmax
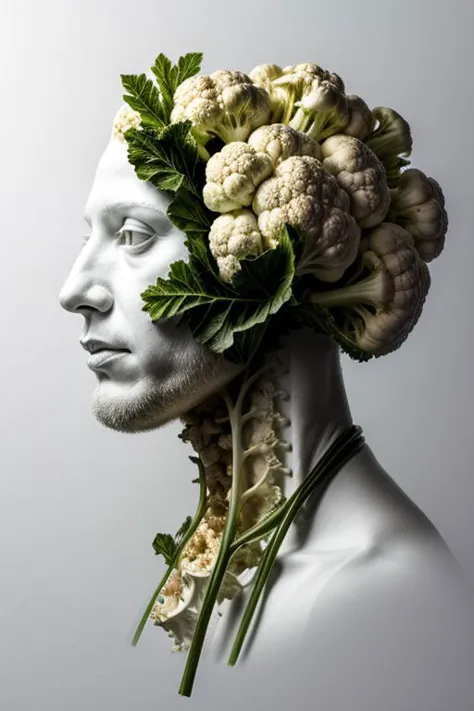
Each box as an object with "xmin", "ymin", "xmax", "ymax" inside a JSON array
[{"xmin": 125, "ymin": 121, "xmax": 203, "ymax": 196}]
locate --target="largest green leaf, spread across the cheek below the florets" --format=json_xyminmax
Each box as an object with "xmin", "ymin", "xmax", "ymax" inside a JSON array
[{"xmin": 141, "ymin": 227, "xmax": 295, "ymax": 364}]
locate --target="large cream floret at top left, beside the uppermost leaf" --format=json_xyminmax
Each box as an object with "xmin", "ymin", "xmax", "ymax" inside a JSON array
[{"xmin": 171, "ymin": 70, "xmax": 271, "ymax": 157}]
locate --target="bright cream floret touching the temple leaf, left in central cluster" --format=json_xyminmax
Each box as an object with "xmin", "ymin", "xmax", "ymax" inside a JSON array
[{"xmin": 202, "ymin": 141, "xmax": 273, "ymax": 212}]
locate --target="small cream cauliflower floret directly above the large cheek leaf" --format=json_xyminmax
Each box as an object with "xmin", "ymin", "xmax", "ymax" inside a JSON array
[{"xmin": 209, "ymin": 210, "xmax": 264, "ymax": 282}]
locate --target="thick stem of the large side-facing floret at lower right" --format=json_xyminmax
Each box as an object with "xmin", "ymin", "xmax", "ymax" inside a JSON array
[{"xmin": 309, "ymin": 251, "xmax": 393, "ymax": 309}]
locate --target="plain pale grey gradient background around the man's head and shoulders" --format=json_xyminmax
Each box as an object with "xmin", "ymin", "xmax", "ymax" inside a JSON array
[{"xmin": 0, "ymin": 0, "xmax": 474, "ymax": 711}]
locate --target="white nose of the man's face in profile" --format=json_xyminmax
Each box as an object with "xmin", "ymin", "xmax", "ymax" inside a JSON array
[{"xmin": 59, "ymin": 256, "xmax": 114, "ymax": 313}]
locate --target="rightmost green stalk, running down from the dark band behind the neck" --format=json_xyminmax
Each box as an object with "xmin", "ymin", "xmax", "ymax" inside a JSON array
[{"xmin": 228, "ymin": 425, "xmax": 365, "ymax": 666}]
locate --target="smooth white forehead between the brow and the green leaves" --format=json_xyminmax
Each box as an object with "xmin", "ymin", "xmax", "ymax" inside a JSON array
[{"xmin": 85, "ymin": 140, "xmax": 171, "ymax": 216}]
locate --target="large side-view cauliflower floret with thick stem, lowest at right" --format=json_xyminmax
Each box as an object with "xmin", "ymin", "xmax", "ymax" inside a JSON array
[{"xmin": 309, "ymin": 222, "xmax": 430, "ymax": 356}]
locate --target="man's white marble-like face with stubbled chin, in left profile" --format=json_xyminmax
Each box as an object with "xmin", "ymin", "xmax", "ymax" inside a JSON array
[{"xmin": 59, "ymin": 140, "xmax": 239, "ymax": 432}]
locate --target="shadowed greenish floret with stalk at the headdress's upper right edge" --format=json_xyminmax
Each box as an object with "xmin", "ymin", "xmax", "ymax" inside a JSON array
[{"xmin": 365, "ymin": 106, "xmax": 413, "ymax": 188}]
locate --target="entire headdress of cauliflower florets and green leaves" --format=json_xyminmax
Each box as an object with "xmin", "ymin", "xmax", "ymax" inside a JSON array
[{"xmin": 113, "ymin": 53, "xmax": 448, "ymax": 364}]
